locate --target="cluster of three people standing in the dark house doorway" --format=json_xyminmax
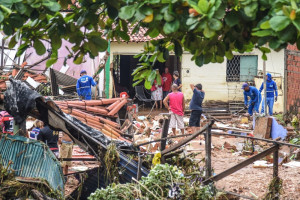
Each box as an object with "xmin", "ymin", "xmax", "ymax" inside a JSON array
[{"xmin": 151, "ymin": 67, "xmax": 182, "ymax": 109}]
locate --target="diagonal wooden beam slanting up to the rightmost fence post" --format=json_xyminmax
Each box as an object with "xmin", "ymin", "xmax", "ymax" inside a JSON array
[{"xmin": 203, "ymin": 145, "xmax": 278, "ymax": 184}]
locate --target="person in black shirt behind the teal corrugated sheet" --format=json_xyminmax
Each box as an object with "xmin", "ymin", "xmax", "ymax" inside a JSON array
[{"xmin": 37, "ymin": 125, "xmax": 59, "ymax": 157}]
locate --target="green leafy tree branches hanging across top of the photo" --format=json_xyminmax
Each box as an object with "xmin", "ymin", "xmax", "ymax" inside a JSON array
[{"xmin": 0, "ymin": 0, "xmax": 300, "ymax": 66}]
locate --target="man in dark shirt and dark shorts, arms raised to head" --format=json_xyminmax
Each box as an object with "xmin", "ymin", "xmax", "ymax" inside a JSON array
[{"xmin": 189, "ymin": 83, "xmax": 205, "ymax": 132}]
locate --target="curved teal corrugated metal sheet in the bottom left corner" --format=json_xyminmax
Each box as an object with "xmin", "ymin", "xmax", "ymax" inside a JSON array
[{"xmin": 0, "ymin": 135, "xmax": 64, "ymax": 197}]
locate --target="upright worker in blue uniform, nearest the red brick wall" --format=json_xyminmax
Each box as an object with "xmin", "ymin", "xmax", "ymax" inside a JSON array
[{"xmin": 259, "ymin": 73, "xmax": 278, "ymax": 116}]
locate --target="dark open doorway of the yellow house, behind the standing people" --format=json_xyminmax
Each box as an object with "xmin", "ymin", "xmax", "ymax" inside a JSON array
[{"xmin": 113, "ymin": 55, "xmax": 181, "ymax": 98}]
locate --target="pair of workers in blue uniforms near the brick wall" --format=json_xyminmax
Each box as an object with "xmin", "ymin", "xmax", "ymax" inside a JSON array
[{"xmin": 242, "ymin": 73, "xmax": 278, "ymax": 116}]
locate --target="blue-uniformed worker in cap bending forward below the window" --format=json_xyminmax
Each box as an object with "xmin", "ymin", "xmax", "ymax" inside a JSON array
[{"xmin": 242, "ymin": 83, "xmax": 261, "ymax": 116}]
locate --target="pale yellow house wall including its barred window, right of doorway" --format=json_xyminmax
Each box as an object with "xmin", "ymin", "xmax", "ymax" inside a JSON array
[{"xmin": 182, "ymin": 50, "xmax": 284, "ymax": 112}]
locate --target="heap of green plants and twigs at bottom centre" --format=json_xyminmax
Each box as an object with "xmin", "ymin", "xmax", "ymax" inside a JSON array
[{"xmin": 89, "ymin": 164, "xmax": 216, "ymax": 200}]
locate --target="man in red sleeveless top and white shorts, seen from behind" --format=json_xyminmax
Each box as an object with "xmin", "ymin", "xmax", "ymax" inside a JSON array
[{"xmin": 164, "ymin": 84, "xmax": 185, "ymax": 135}]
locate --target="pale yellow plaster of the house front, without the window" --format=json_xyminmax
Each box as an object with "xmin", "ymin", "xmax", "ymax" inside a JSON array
[{"xmin": 110, "ymin": 42, "xmax": 284, "ymax": 112}]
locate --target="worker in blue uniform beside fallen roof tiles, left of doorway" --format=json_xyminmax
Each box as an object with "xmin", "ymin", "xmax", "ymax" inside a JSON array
[{"xmin": 76, "ymin": 70, "xmax": 96, "ymax": 100}]
